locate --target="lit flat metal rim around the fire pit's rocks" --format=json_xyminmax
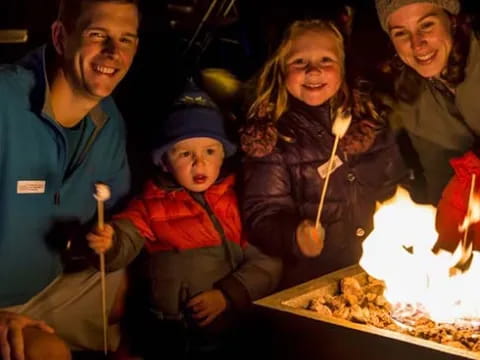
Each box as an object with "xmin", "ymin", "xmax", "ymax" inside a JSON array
[{"xmin": 254, "ymin": 265, "xmax": 480, "ymax": 359}]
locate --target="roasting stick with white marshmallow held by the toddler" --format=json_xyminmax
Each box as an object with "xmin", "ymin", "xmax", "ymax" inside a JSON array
[{"xmin": 93, "ymin": 183, "xmax": 110, "ymax": 356}]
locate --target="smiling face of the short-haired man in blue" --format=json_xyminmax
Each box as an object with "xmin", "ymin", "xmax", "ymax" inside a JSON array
[{"xmin": 58, "ymin": 2, "xmax": 139, "ymax": 99}]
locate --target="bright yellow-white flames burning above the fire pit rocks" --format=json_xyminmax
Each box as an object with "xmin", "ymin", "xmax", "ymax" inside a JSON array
[{"xmin": 360, "ymin": 188, "xmax": 480, "ymax": 326}]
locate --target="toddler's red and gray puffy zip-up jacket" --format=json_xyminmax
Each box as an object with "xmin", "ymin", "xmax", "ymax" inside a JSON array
[{"xmin": 102, "ymin": 176, "xmax": 281, "ymax": 318}]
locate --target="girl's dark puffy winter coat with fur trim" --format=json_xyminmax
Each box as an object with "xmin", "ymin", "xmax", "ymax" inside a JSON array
[{"xmin": 242, "ymin": 101, "xmax": 405, "ymax": 287}]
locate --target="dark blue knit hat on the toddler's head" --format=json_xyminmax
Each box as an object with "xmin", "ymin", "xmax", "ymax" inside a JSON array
[{"xmin": 152, "ymin": 82, "xmax": 236, "ymax": 166}]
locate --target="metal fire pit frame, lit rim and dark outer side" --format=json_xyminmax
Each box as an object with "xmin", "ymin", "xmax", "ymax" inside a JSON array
[{"xmin": 255, "ymin": 265, "xmax": 480, "ymax": 360}]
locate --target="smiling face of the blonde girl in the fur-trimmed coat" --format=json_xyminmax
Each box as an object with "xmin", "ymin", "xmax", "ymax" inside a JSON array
[{"xmin": 285, "ymin": 30, "xmax": 342, "ymax": 106}]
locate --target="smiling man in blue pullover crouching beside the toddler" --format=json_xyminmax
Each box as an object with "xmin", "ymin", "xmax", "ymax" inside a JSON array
[{"xmin": 0, "ymin": 0, "xmax": 139, "ymax": 360}]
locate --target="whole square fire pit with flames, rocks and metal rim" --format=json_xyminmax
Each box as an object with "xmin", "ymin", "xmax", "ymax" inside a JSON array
[{"xmin": 256, "ymin": 189, "xmax": 480, "ymax": 360}]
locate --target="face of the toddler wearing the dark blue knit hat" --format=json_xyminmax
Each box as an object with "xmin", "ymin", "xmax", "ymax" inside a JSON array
[{"xmin": 167, "ymin": 137, "xmax": 225, "ymax": 192}]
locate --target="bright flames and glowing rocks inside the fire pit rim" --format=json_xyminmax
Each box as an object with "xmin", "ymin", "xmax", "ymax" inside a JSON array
[{"xmin": 308, "ymin": 189, "xmax": 480, "ymax": 351}]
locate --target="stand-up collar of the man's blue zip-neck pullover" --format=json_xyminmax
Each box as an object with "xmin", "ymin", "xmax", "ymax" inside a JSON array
[{"xmin": 17, "ymin": 45, "xmax": 108, "ymax": 127}]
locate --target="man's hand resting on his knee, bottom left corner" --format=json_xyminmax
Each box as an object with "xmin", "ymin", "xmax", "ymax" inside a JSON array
[{"xmin": 0, "ymin": 311, "xmax": 54, "ymax": 360}]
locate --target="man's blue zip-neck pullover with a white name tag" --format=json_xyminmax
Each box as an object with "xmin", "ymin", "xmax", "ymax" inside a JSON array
[{"xmin": 0, "ymin": 47, "xmax": 130, "ymax": 308}]
